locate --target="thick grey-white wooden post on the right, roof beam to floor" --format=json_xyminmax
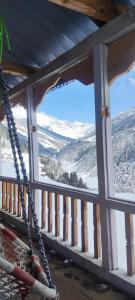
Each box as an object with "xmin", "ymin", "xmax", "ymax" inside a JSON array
[{"xmin": 94, "ymin": 44, "xmax": 118, "ymax": 270}]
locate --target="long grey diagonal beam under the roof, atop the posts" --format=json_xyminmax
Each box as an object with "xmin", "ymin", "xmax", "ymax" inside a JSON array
[{"xmin": 10, "ymin": 7, "xmax": 135, "ymax": 97}]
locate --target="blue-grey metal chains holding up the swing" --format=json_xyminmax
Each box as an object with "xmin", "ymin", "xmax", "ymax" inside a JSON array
[{"xmin": 0, "ymin": 69, "xmax": 55, "ymax": 288}]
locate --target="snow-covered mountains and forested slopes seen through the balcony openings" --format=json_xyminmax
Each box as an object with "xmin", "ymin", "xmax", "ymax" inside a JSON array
[{"xmin": 0, "ymin": 107, "xmax": 135, "ymax": 192}]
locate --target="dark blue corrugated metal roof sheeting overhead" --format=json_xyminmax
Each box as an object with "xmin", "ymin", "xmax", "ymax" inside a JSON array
[{"xmin": 0, "ymin": 0, "xmax": 98, "ymax": 86}]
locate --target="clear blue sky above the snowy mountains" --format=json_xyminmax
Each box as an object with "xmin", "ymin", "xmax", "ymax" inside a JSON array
[{"xmin": 38, "ymin": 67, "xmax": 135, "ymax": 123}]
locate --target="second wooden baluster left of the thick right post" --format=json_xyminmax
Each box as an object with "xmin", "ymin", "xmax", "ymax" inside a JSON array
[{"xmin": 81, "ymin": 201, "xmax": 88, "ymax": 252}]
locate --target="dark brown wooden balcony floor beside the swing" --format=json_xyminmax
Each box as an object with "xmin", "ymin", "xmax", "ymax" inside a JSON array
[{"xmin": 8, "ymin": 227, "xmax": 129, "ymax": 300}]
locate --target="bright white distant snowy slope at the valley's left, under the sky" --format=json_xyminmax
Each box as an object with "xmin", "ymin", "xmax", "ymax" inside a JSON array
[{"xmin": 2, "ymin": 106, "xmax": 94, "ymax": 155}]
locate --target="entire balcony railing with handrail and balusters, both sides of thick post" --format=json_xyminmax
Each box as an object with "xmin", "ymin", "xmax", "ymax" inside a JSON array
[{"xmin": 0, "ymin": 177, "xmax": 135, "ymax": 294}]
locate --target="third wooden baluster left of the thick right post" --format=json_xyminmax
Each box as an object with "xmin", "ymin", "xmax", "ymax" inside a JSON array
[{"xmin": 71, "ymin": 198, "xmax": 78, "ymax": 246}]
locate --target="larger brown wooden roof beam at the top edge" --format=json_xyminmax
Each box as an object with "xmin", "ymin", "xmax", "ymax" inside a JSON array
[{"xmin": 48, "ymin": 0, "xmax": 127, "ymax": 23}]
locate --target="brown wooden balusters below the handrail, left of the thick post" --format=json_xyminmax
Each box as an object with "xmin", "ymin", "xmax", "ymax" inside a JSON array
[{"xmin": 1, "ymin": 179, "xmax": 101, "ymax": 258}]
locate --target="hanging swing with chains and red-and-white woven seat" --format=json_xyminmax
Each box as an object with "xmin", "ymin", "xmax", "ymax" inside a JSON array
[{"xmin": 0, "ymin": 17, "xmax": 58, "ymax": 299}]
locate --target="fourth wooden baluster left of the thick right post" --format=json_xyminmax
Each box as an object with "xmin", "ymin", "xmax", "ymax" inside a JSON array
[{"xmin": 63, "ymin": 196, "xmax": 69, "ymax": 241}]
